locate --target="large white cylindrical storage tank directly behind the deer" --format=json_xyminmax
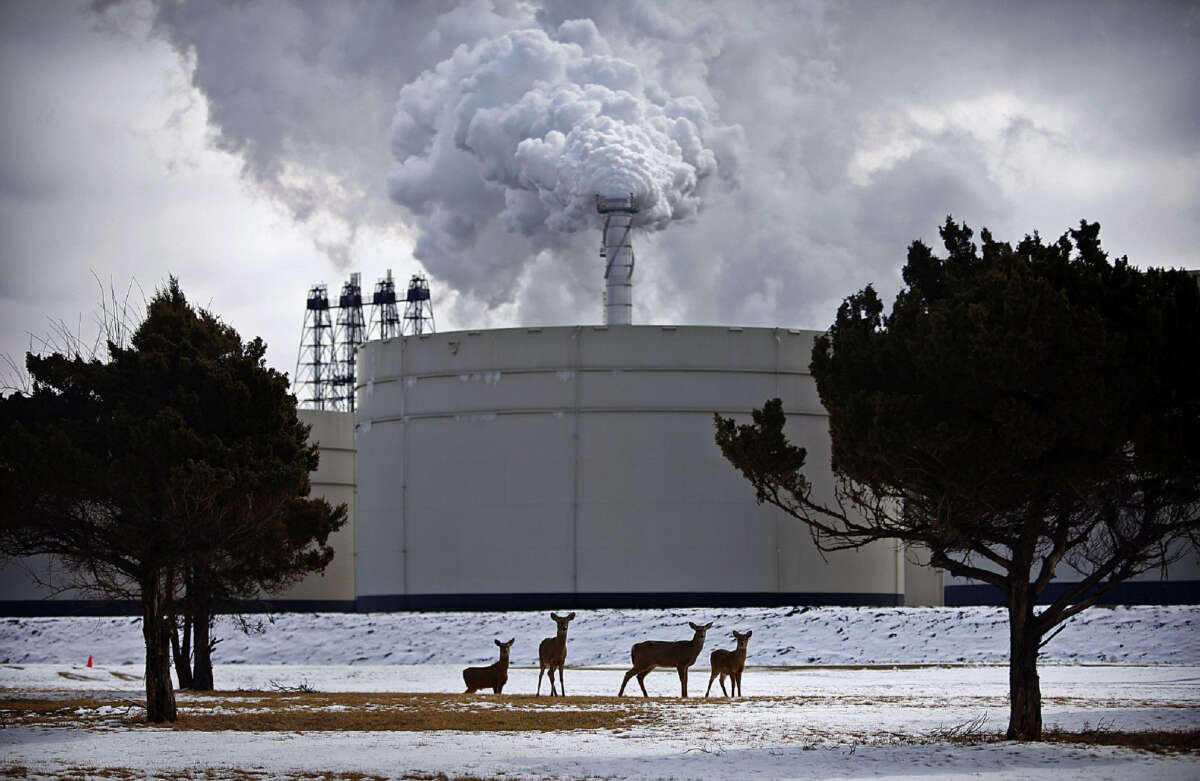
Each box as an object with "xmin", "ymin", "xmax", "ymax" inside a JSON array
[{"xmin": 355, "ymin": 325, "xmax": 905, "ymax": 611}]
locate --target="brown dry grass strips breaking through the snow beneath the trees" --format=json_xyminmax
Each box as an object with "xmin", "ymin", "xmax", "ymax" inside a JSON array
[{"xmin": 0, "ymin": 691, "xmax": 1200, "ymax": 758}]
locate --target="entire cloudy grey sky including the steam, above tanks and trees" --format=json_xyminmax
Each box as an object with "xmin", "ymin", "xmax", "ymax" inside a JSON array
[{"xmin": 0, "ymin": 0, "xmax": 1200, "ymax": 383}]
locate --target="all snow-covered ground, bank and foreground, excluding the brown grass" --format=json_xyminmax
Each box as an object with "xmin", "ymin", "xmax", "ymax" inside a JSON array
[{"xmin": 0, "ymin": 607, "xmax": 1200, "ymax": 780}]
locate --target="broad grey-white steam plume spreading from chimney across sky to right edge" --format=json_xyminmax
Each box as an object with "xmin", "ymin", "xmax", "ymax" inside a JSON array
[{"xmin": 136, "ymin": 0, "xmax": 1200, "ymax": 329}]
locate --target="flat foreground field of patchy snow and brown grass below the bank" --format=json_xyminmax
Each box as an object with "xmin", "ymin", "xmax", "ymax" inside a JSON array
[{"xmin": 0, "ymin": 665, "xmax": 1200, "ymax": 781}]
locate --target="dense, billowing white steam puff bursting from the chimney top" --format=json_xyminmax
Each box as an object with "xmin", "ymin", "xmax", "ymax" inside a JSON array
[{"xmin": 390, "ymin": 19, "xmax": 743, "ymax": 275}]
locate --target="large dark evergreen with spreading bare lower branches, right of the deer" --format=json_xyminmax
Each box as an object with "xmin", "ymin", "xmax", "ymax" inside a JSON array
[{"xmin": 715, "ymin": 218, "xmax": 1200, "ymax": 740}]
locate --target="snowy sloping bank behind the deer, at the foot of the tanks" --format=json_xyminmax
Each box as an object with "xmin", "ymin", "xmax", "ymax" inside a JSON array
[{"xmin": 0, "ymin": 606, "xmax": 1200, "ymax": 666}]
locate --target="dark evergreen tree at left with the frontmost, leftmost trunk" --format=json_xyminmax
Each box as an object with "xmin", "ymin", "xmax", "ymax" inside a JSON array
[{"xmin": 0, "ymin": 278, "xmax": 346, "ymax": 722}]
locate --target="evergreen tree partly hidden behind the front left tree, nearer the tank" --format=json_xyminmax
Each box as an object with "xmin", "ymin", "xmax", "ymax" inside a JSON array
[{"xmin": 127, "ymin": 284, "xmax": 346, "ymax": 690}]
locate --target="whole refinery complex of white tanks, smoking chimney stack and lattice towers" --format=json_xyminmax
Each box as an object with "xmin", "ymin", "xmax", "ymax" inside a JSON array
[{"xmin": 0, "ymin": 194, "xmax": 1200, "ymax": 614}]
